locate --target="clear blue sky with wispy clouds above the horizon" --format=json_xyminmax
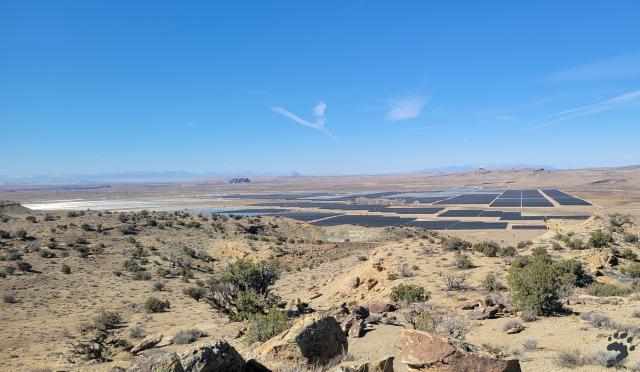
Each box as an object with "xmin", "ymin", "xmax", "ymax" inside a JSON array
[{"xmin": 0, "ymin": 0, "xmax": 640, "ymax": 176}]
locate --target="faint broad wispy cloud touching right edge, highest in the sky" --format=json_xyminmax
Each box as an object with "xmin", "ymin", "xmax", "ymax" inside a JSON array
[{"xmin": 547, "ymin": 53, "xmax": 640, "ymax": 82}]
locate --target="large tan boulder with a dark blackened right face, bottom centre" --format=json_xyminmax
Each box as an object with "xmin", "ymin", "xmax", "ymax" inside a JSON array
[{"xmin": 252, "ymin": 313, "xmax": 355, "ymax": 369}]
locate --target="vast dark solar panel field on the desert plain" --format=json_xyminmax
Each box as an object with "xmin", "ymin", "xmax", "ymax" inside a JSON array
[{"xmin": 221, "ymin": 186, "xmax": 591, "ymax": 230}]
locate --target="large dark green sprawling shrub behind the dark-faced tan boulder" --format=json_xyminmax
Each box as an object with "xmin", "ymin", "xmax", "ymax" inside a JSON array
[{"xmin": 206, "ymin": 259, "xmax": 279, "ymax": 320}]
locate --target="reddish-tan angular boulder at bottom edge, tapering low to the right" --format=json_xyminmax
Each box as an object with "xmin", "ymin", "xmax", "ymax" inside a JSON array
[{"xmin": 400, "ymin": 330, "xmax": 521, "ymax": 372}]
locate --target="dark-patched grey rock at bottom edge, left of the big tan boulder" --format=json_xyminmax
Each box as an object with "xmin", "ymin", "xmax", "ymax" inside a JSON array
[{"xmin": 129, "ymin": 340, "xmax": 249, "ymax": 372}]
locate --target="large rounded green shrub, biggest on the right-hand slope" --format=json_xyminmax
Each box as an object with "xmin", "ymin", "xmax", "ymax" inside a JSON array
[{"xmin": 507, "ymin": 255, "xmax": 561, "ymax": 314}]
